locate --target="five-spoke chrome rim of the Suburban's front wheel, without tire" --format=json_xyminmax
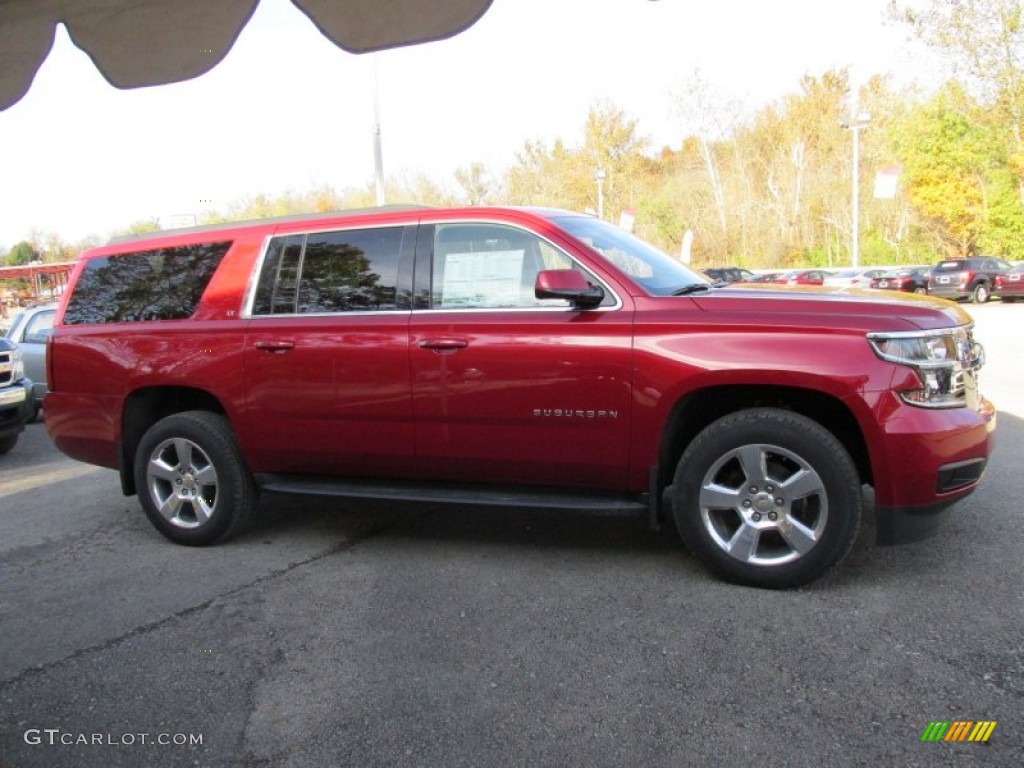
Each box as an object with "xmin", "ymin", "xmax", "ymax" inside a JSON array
[{"xmin": 698, "ymin": 443, "xmax": 828, "ymax": 565}]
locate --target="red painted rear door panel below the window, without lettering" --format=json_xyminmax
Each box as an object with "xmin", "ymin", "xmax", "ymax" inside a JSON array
[{"xmin": 238, "ymin": 312, "xmax": 413, "ymax": 477}]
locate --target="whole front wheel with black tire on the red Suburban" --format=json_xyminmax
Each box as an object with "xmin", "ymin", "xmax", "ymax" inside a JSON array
[{"xmin": 672, "ymin": 408, "xmax": 862, "ymax": 589}]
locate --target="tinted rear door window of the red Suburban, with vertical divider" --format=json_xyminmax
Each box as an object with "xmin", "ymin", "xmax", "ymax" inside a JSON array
[{"xmin": 253, "ymin": 226, "xmax": 408, "ymax": 314}]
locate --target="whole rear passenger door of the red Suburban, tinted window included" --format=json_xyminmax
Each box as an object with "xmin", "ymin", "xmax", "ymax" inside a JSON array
[{"xmin": 244, "ymin": 225, "xmax": 416, "ymax": 477}]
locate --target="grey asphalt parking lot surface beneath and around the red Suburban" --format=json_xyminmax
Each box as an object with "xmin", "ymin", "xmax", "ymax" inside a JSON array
[{"xmin": 0, "ymin": 303, "xmax": 1024, "ymax": 768}]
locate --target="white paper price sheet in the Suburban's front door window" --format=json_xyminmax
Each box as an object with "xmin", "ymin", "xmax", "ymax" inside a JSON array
[{"xmin": 442, "ymin": 250, "xmax": 525, "ymax": 307}]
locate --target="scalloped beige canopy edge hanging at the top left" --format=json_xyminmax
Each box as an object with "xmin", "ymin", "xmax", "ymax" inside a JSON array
[{"xmin": 0, "ymin": 0, "xmax": 492, "ymax": 111}]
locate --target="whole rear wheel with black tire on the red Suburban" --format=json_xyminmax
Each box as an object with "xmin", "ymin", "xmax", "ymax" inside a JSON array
[{"xmin": 135, "ymin": 411, "xmax": 258, "ymax": 546}]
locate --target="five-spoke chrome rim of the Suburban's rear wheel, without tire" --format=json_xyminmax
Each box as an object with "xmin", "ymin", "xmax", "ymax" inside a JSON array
[{"xmin": 145, "ymin": 437, "xmax": 217, "ymax": 528}]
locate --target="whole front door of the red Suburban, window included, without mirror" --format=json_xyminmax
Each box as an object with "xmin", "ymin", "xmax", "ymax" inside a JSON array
[{"xmin": 410, "ymin": 222, "xmax": 633, "ymax": 488}]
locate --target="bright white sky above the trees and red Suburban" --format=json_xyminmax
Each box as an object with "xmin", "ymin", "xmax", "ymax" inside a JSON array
[{"xmin": 0, "ymin": 0, "xmax": 920, "ymax": 248}]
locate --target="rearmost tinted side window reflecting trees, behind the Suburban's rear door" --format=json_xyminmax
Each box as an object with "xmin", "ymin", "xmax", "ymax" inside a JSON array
[{"xmin": 63, "ymin": 242, "xmax": 231, "ymax": 325}]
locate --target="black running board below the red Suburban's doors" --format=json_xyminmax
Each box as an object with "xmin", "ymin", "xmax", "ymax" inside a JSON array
[{"xmin": 256, "ymin": 474, "xmax": 649, "ymax": 513}]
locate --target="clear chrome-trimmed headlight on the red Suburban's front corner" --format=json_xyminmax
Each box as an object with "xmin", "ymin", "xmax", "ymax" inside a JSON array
[{"xmin": 867, "ymin": 327, "xmax": 985, "ymax": 408}]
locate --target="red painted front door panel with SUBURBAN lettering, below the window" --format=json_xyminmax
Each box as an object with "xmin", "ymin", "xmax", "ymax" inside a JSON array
[{"xmin": 410, "ymin": 309, "xmax": 633, "ymax": 489}]
